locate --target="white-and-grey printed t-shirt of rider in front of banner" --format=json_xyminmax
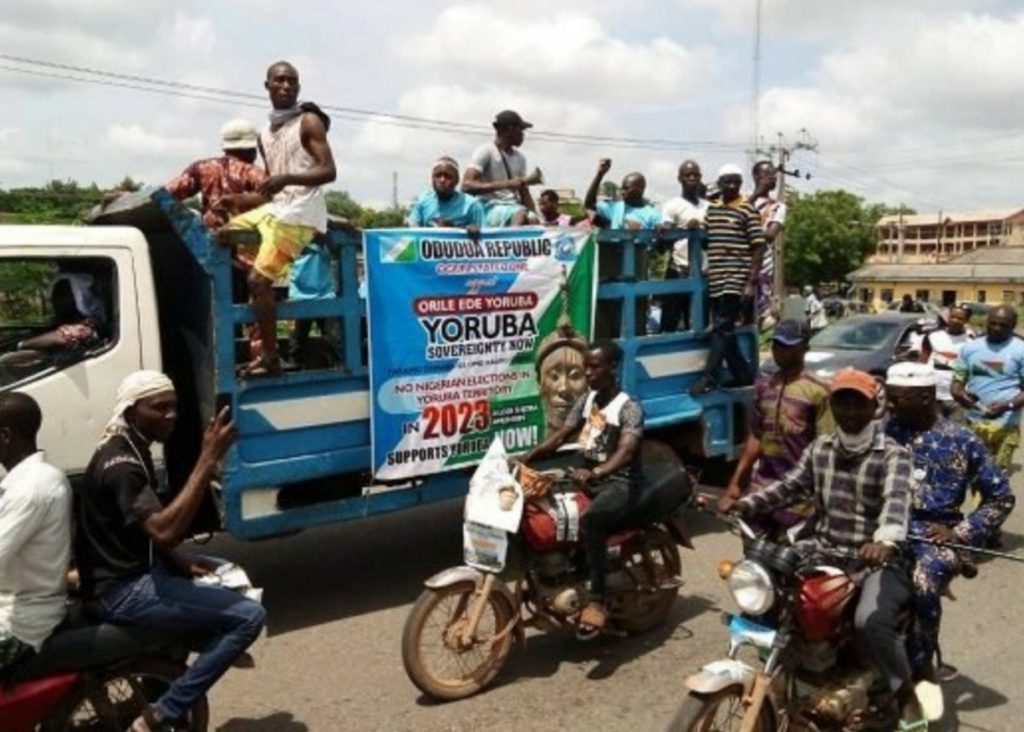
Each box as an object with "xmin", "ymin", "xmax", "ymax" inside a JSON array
[{"xmin": 565, "ymin": 391, "xmax": 643, "ymax": 486}]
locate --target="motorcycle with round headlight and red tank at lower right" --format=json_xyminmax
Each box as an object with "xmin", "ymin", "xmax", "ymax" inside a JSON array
[{"xmin": 669, "ymin": 518, "xmax": 942, "ymax": 732}]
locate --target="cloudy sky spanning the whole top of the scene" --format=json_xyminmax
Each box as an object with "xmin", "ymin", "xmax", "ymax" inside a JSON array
[{"xmin": 0, "ymin": 0, "xmax": 1024, "ymax": 212}]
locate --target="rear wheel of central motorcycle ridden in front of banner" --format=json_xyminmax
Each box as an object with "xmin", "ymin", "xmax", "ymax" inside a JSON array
[{"xmin": 615, "ymin": 529, "xmax": 682, "ymax": 633}]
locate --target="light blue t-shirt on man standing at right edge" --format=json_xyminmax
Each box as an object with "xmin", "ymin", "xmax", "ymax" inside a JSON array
[{"xmin": 953, "ymin": 336, "xmax": 1024, "ymax": 427}]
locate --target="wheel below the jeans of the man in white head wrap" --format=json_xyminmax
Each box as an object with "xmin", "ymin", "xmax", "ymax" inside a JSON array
[{"xmin": 42, "ymin": 658, "xmax": 210, "ymax": 732}]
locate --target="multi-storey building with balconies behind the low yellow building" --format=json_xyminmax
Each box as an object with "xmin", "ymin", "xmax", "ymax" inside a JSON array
[{"xmin": 868, "ymin": 209, "xmax": 1024, "ymax": 264}]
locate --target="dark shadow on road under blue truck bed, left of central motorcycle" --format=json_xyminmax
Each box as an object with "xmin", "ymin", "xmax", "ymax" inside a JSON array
[{"xmin": 201, "ymin": 500, "xmax": 462, "ymax": 638}]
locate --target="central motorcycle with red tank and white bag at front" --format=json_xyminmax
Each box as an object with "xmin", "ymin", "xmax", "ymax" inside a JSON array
[{"xmin": 401, "ymin": 445, "xmax": 692, "ymax": 700}]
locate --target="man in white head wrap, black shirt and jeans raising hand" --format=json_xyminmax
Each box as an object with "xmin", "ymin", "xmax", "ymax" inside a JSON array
[{"xmin": 75, "ymin": 371, "xmax": 265, "ymax": 732}]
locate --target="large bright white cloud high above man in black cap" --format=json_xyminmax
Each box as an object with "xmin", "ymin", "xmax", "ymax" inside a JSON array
[{"xmin": 399, "ymin": 5, "xmax": 714, "ymax": 105}]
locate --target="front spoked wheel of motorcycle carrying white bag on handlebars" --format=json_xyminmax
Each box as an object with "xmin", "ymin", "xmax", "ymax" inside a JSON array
[{"xmin": 401, "ymin": 582, "xmax": 514, "ymax": 701}]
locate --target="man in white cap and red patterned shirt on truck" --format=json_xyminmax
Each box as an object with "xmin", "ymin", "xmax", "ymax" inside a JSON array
[{"xmin": 165, "ymin": 120, "xmax": 266, "ymax": 230}]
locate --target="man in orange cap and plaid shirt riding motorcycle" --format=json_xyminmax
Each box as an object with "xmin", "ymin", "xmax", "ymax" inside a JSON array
[{"xmin": 720, "ymin": 370, "xmax": 928, "ymax": 731}]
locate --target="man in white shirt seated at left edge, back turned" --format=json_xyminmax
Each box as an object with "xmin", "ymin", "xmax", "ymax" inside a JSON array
[{"xmin": 0, "ymin": 391, "xmax": 72, "ymax": 672}]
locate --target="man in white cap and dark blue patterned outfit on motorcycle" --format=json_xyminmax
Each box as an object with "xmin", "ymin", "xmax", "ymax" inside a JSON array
[{"xmin": 886, "ymin": 362, "xmax": 1014, "ymax": 682}]
